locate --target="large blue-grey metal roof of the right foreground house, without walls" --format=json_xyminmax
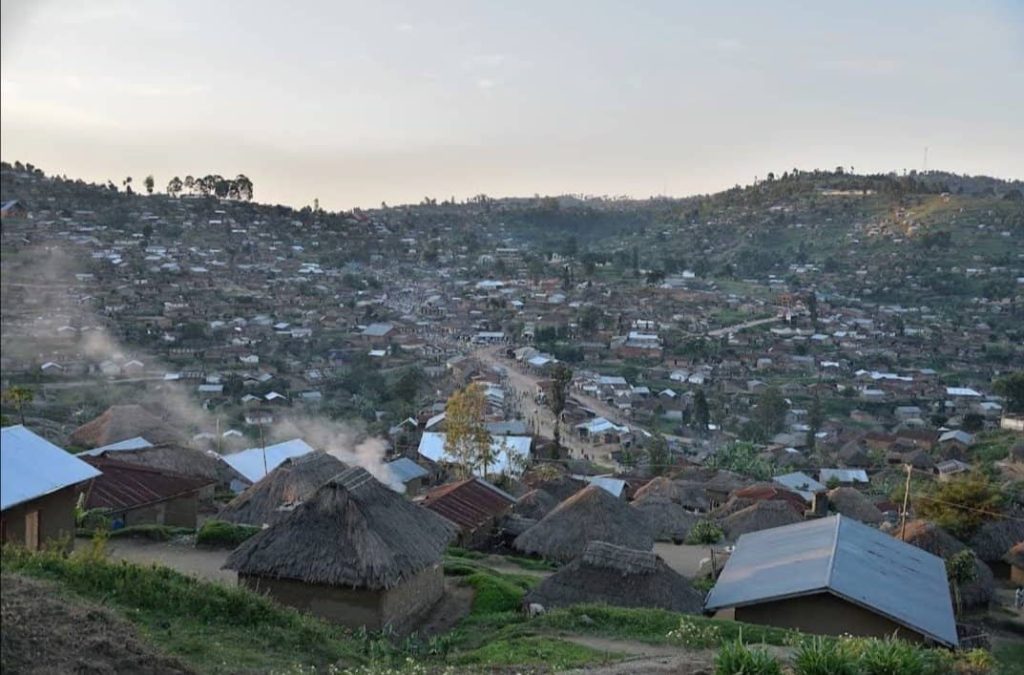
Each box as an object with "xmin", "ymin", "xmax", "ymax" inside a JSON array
[{"xmin": 705, "ymin": 516, "xmax": 956, "ymax": 646}]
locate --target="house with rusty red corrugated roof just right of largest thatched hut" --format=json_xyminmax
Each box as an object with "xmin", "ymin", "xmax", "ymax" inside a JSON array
[{"xmin": 421, "ymin": 476, "xmax": 516, "ymax": 548}]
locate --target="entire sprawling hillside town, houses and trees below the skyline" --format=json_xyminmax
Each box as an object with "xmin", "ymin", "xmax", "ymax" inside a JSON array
[{"xmin": 0, "ymin": 162, "xmax": 1024, "ymax": 672}]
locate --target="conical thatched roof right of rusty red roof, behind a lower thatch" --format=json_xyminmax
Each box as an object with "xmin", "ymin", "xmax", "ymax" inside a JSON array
[{"xmin": 512, "ymin": 486, "xmax": 654, "ymax": 560}]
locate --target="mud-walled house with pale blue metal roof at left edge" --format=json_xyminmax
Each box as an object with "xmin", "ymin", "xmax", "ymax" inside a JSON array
[{"xmin": 0, "ymin": 424, "xmax": 99, "ymax": 550}]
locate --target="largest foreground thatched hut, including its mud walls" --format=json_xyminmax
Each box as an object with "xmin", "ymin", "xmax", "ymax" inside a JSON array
[{"xmin": 224, "ymin": 467, "xmax": 455, "ymax": 632}]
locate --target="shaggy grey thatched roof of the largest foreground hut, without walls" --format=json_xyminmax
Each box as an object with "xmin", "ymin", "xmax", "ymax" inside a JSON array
[{"xmin": 224, "ymin": 467, "xmax": 456, "ymax": 590}]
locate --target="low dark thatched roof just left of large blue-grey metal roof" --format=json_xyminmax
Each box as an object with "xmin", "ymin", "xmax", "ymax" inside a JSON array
[{"xmin": 523, "ymin": 542, "xmax": 703, "ymax": 614}]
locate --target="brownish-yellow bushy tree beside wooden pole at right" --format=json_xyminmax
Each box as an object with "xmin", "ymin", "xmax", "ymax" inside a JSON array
[{"xmin": 915, "ymin": 472, "xmax": 1002, "ymax": 540}]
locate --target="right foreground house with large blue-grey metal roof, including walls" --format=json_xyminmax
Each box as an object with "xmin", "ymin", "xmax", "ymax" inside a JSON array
[{"xmin": 705, "ymin": 515, "xmax": 957, "ymax": 647}]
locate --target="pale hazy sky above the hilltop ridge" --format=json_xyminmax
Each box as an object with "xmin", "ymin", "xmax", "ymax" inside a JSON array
[{"xmin": 0, "ymin": 0, "xmax": 1024, "ymax": 208}]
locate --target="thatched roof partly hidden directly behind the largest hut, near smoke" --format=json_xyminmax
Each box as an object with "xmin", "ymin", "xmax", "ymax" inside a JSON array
[{"xmin": 217, "ymin": 453, "xmax": 345, "ymax": 525}]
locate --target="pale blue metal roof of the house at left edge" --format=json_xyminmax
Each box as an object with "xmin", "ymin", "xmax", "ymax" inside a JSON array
[{"xmin": 0, "ymin": 424, "xmax": 99, "ymax": 510}]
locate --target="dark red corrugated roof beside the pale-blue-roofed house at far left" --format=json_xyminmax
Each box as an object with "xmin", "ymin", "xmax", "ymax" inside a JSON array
[{"xmin": 87, "ymin": 457, "xmax": 212, "ymax": 511}]
